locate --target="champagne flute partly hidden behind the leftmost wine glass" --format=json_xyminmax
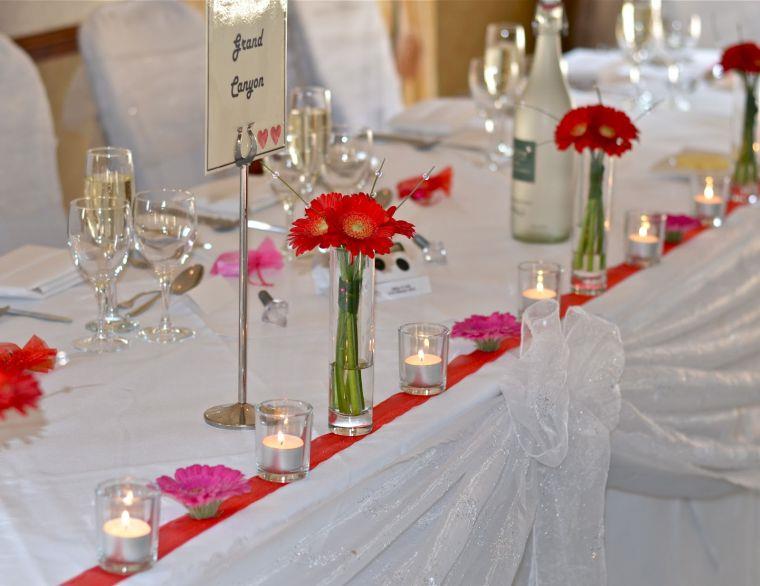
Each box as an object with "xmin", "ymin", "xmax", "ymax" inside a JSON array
[{"xmin": 84, "ymin": 146, "xmax": 139, "ymax": 333}]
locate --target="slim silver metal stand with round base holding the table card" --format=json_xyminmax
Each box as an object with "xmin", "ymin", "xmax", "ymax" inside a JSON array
[{"xmin": 203, "ymin": 123, "xmax": 257, "ymax": 429}]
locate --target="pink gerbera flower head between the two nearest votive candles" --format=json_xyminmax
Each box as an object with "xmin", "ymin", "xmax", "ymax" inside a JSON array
[{"xmin": 156, "ymin": 464, "xmax": 251, "ymax": 519}]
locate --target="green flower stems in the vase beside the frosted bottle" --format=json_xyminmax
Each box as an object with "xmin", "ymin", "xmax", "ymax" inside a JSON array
[{"xmin": 573, "ymin": 151, "xmax": 607, "ymax": 272}]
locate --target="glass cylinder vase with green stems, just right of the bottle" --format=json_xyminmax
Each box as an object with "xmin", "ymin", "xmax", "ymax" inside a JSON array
[{"xmin": 570, "ymin": 150, "xmax": 614, "ymax": 295}]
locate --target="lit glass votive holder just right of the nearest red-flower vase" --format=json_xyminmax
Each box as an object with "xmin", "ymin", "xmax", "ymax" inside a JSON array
[{"xmin": 398, "ymin": 323, "xmax": 449, "ymax": 396}]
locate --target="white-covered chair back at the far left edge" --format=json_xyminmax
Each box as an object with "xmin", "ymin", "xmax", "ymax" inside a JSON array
[{"xmin": 0, "ymin": 35, "xmax": 66, "ymax": 254}]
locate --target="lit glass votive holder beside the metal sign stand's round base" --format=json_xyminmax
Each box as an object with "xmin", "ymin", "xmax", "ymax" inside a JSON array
[{"xmin": 256, "ymin": 399, "xmax": 314, "ymax": 484}]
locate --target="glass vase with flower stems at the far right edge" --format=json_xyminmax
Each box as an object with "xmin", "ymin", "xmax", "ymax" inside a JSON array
[{"xmin": 731, "ymin": 73, "xmax": 760, "ymax": 204}]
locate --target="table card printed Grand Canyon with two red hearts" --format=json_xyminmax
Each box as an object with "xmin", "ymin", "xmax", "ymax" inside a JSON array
[{"xmin": 206, "ymin": 0, "xmax": 287, "ymax": 173}]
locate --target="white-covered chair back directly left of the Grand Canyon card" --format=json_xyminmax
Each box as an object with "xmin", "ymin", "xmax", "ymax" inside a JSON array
[{"xmin": 79, "ymin": 0, "xmax": 214, "ymax": 189}]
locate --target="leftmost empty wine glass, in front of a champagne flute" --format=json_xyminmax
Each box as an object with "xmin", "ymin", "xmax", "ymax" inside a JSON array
[{"xmin": 68, "ymin": 197, "xmax": 132, "ymax": 352}]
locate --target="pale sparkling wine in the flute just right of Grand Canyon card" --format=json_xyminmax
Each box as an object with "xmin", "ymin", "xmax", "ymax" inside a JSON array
[{"xmin": 288, "ymin": 107, "xmax": 330, "ymax": 182}]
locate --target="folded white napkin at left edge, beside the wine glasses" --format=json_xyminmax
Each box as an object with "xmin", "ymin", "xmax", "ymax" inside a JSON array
[{"xmin": 0, "ymin": 245, "xmax": 82, "ymax": 299}]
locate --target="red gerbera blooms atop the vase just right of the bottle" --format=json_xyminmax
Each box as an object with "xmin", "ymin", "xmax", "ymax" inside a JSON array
[{"xmin": 554, "ymin": 104, "xmax": 639, "ymax": 156}]
